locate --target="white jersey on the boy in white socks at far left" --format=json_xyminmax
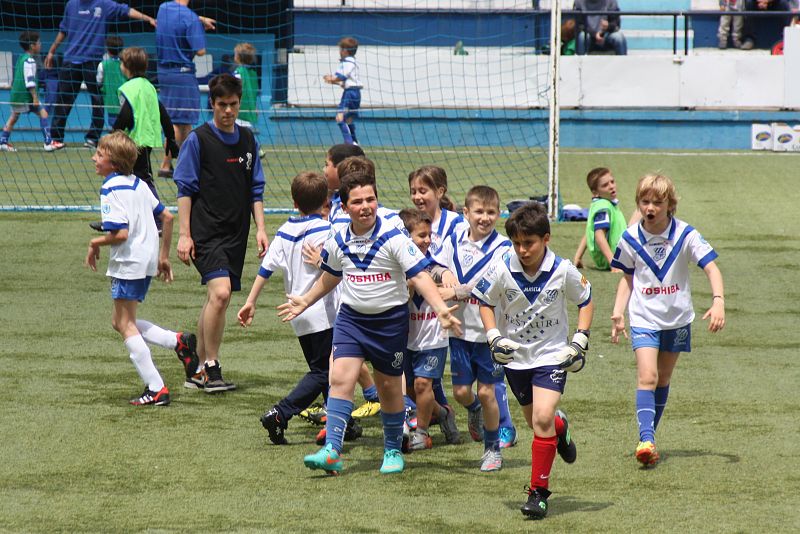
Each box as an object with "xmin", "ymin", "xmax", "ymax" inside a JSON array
[{"xmin": 100, "ymin": 173, "xmax": 164, "ymax": 280}]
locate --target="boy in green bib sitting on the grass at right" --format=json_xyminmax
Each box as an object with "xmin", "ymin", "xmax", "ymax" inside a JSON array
[{"xmin": 572, "ymin": 167, "xmax": 640, "ymax": 271}]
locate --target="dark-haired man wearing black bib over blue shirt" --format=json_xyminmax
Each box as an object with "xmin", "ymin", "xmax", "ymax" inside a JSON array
[{"xmin": 174, "ymin": 74, "xmax": 269, "ymax": 393}]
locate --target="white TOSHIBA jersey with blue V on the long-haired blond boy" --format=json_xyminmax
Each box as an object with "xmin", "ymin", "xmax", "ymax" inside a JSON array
[{"xmin": 611, "ymin": 218, "xmax": 717, "ymax": 330}]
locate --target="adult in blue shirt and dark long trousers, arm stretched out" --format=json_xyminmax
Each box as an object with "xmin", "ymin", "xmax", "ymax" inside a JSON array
[{"xmin": 44, "ymin": 0, "xmax": 156, "ymax": 148}]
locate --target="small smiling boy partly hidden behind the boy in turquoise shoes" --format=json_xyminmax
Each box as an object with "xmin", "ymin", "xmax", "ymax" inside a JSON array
[{"xmin": 399, "ymin": 209, "xmax": 461, "ymax": 451}]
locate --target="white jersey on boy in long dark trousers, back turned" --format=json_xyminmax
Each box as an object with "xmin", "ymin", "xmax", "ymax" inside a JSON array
[{"xmin": 258, "ymin": 215, "xmax": 336, "ymax": 336}]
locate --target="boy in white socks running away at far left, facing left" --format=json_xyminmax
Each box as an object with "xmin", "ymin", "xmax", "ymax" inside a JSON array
[{"xmin": 85, "ymin": 132, "xmax": 198, "ymax": 406}]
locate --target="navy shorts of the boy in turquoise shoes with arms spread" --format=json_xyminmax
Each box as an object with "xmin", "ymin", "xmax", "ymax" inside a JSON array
[{"xmin": 333, "ymin": 304, "xmax": 408, "ymax": 376}]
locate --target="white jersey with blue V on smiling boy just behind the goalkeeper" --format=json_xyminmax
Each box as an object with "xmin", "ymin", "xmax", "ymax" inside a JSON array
[{"xmin": 433, "ymin": 227, "xmax": 511, "ymax": 342}]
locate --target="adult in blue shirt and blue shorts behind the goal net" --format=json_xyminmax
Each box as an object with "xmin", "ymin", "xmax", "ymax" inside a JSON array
[{"xmin": 156, "ymin": 0, "xmax": 216, "ymax": 177}]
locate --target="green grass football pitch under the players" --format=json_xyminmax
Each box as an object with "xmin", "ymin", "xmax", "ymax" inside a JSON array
[{"xmin": 0, "ymin": 149, "xmax": 800, "ymax": 533}]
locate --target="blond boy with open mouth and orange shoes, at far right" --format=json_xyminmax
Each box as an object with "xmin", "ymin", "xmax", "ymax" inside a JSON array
[{"xmin": 611, "ymin": 174, "xmax": 725, "ymax": 466}]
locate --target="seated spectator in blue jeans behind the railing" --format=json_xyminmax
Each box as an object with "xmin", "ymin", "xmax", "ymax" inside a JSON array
[{"xmin": 574, "ymin": 0, "xmax": 628, "ymax": 56}]
